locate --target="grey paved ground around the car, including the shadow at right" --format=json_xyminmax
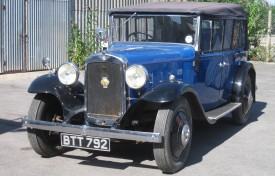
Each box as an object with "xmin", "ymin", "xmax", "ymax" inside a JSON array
[{"xmin": 0, "ymin": 62, "xmax": 275, "ymax": 176}]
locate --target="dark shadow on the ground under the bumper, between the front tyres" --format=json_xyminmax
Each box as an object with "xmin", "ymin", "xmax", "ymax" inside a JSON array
[{"xmin": 61, "ymin": 143, "xmax": 158, "ymax": 170}]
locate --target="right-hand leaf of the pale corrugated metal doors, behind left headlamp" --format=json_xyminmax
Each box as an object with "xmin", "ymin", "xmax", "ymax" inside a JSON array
[{"xmin": 27, "ymin": 0, "xmax": 69, "ymax": 70}]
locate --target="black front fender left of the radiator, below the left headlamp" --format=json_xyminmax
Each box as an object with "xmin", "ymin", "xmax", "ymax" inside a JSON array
[{"xmin": 28, "ymin": 74, "xmax": 84, "ymax": 121}]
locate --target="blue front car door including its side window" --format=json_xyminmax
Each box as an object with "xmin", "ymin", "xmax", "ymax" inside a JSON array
[{"xmin": 195, "ymin": 19, "xmax": 224, "ymax": 111}]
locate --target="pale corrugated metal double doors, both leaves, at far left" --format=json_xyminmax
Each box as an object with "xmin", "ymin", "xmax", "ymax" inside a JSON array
[{"xmin": 0, "ymin": 0, "xmax": 70, "ymax": 73}]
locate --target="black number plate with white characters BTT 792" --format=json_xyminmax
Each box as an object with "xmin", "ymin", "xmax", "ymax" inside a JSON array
[{"xmin": 60, "ymin": 133, "xmax": 110, "ymax": 151}]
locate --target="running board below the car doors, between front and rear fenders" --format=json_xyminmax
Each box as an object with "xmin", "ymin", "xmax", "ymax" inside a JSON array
[{"xmin": 205, "ymin": 103, "xmax": 242, "ymax": 120}]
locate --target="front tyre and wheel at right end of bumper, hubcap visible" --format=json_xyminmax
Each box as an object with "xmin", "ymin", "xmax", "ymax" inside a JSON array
[{"xmin": 153, "ymin": 97, "xmax": 192, "ymax": 173}]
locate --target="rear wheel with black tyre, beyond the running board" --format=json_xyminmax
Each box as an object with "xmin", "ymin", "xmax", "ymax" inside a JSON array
[{"xmin": 232, "ymin": 74, "xmax": 254, "ymax": 125}]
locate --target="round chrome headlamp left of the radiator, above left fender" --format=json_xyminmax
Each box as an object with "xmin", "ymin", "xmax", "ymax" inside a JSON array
[{"xmin": 57, "ymin": 62, "xmax": 79, "ymax": 85}]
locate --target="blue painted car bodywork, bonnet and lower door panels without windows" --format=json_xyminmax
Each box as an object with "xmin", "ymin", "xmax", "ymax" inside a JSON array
[{"xmin": 90, "ymin": 42, "xmax": 245, "ymax": 111}]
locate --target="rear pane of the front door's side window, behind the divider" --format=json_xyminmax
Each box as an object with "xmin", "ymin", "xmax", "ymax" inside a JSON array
[{"xmin": 211, "ymin": 20, "xmax": 224, "ymax": 51}]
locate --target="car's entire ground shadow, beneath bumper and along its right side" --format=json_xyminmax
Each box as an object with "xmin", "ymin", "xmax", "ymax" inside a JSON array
[{"xmin": 61, "ymin": 102, "xmax": 266, "ymax": 170}]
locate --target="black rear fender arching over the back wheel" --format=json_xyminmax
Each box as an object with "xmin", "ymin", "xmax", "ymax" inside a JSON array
[{"xmin": 232, "ymin": 61, "xmax": 256, "ymax": 102}]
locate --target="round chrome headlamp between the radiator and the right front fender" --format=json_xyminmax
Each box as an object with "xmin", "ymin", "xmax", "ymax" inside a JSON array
[{"xmin": 126, "ymin": 65, "xmax": 148, "ymax": 89}]
